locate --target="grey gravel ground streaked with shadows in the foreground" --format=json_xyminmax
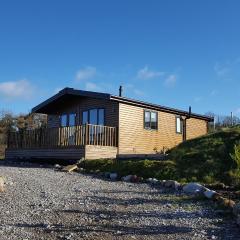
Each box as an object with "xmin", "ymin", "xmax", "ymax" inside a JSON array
[{"xmin": 0, "ymin": 164, "xmax": 240, "ymax": 240}]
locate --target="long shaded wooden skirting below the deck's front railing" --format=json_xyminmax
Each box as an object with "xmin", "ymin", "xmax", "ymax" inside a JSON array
[{"xmin": 5, "ymin": 146, "xmax": 85, "ymax": 160}]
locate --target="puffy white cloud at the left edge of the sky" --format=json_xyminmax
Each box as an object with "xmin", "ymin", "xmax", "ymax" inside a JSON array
[{"xmin": 0, "ymin": 79, "xmax": 34, "ymax": 101}]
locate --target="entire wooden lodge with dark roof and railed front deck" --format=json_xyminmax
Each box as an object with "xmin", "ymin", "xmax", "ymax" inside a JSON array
[{"xmin": 5, "ymin": 88, "xmax": 213, "ymax": 160}]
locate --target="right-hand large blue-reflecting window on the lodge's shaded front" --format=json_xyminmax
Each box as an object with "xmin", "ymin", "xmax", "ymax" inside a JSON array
[{"xmin": 82, "ymin": 108, "xmax": 105, "ymax": 125}]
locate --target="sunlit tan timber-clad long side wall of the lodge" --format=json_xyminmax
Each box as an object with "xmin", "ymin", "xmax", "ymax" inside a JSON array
[{"xmin": 118, "ymin": 103, "xmax": 207, "ymax": 155}]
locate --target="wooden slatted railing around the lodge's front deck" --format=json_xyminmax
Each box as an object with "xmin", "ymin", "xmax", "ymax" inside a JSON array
[{"xmin": 8, "ymin": 124, "xmax": 117, "ymax": 149}]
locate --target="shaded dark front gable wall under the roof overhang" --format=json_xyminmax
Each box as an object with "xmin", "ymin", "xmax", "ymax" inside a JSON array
[{"xmin": 48, "ymin": 97, "xmax": 118, "ymax": 127}]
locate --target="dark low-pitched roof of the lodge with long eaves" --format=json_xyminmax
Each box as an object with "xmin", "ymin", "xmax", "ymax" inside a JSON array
[{"xmin": 32, "ymin": 88, "xmax": 213, "ymax": 122}]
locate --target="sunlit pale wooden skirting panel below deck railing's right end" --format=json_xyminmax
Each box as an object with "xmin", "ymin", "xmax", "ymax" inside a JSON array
[{"xmin": 85, "ymin": 145, "xmax": 117, "ymax": 160}]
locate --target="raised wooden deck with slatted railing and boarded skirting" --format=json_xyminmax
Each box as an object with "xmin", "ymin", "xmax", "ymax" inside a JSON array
[{"xmin": 5, "ymin": 124, "xmax": 118, "ymax": 160}]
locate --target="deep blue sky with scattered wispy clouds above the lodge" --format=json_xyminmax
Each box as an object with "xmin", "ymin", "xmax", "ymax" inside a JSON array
[{"xmin": 0, "ymin": 0, "xmax": 240, "ymax": 116}]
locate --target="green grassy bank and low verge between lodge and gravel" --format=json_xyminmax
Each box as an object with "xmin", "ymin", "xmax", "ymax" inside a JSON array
[{"xmin": 82, "ymin": 127, "xmax": 240, "ymax": 186}]
